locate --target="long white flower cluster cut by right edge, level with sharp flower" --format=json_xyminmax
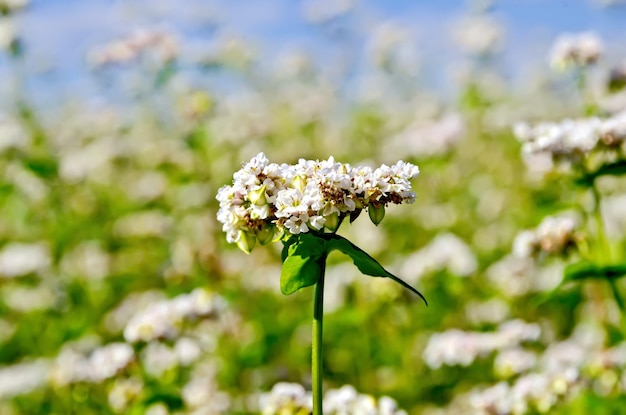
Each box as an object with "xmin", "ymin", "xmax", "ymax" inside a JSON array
[{"xmin": 513, "ymin": 111, "xmax": 626, "ymax": 159}]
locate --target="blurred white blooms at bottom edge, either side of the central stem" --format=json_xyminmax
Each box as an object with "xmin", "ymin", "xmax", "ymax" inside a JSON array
[{"xmin": 260, "ymin": 382, "xmax": 406, "ymax": 415}]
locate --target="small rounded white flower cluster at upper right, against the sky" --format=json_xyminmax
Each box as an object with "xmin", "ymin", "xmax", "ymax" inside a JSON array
[{"xmin": 550, "ymin": 32, "xmax": 602, "ymax": 70}]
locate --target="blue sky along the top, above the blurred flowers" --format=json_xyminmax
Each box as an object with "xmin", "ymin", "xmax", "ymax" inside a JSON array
[{"xmin": 0, "ymin": 0, "xmax": 626, "ymax": 109}]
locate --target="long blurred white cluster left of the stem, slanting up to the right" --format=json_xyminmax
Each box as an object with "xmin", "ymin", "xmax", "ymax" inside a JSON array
[{"xmin": 124, "ymin": 288, "xmax": 226, "ymax": 343}]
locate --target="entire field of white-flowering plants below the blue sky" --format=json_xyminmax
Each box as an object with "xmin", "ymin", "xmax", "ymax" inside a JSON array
[{"xmin": 0, "ymin": 0, "xmax": 626, "ymax": 415}]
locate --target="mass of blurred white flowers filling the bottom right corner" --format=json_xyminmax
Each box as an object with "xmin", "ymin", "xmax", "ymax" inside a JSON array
[{"xmin": 434, "ymin": 322, "xmax": 626, "ymax": 415}]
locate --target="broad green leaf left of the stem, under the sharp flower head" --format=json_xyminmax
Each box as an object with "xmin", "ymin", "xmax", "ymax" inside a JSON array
[{"xmin": 280, "ymin": 233, "xmax": 326, "ymax": 295}]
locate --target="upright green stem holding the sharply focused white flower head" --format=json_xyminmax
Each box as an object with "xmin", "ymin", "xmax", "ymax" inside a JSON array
[{"xmin": 311, "ymin": 256, "xmax": 326, "ymax": 415}]
